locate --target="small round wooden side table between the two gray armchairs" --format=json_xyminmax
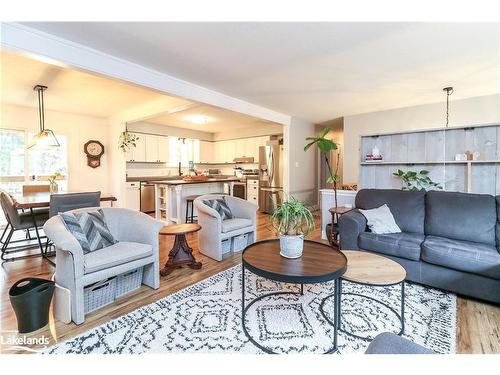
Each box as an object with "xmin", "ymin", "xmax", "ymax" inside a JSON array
[{"xmin": 160, "ymin": 224, "xmax": 201, "ymax": 276}]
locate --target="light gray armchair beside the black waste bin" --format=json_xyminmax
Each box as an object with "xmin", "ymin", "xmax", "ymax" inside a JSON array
[{"xmin": 43, "ymin": 207, "xmax": 164, "ymax": 324}]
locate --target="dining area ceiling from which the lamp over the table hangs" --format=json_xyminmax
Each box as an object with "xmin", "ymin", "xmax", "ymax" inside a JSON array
[{"xmin": 0, "ymin": 51, "xmax": 179, "ymax": 117}]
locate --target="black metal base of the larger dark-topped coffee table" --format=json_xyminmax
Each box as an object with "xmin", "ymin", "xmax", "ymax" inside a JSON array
[{"xmin": 241, "ymin": 264, "xmax": 340, "ymax": 354}]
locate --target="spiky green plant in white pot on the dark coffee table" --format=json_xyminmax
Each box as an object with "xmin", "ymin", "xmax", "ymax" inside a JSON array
[{"xmin": 271, "ymin": 197, "xmax": 314, "ymax": 258}]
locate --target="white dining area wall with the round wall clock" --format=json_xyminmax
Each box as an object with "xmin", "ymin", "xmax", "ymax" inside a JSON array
[{"xmin": 0, "ymin": 103, "xmax": 110, "ymax": 194}]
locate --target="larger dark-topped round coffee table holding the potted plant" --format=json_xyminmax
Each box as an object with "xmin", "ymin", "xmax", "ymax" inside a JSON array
[{"xmin": 241, "ymin": 239, "xmax": 347, "ymax": 354}]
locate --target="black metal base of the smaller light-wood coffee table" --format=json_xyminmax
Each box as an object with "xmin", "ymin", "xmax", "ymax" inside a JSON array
[{"xmin": 320, "ymin": 279, "xmax": 405, "ymax": 341}]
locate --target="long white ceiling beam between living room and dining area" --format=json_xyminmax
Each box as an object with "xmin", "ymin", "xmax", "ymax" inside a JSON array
[{"xmin": 1, "ymin": 23, "xmax": 291, "ymax": 125}]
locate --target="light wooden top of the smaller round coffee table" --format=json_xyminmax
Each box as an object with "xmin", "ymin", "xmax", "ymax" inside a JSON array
[{"xmin": 342, "ymin": 250, "xmax": 406, "ymax": 285}]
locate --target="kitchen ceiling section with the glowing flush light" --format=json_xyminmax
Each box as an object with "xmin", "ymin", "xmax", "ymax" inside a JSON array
[{"xmin": 147, "ymin": 105, "xmax": 280, "ymax": 133}]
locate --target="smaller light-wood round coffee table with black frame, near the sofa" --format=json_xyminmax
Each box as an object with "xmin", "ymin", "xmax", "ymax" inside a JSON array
[{"xmin": 320, "ymin": 250, "xmax": 406, "ymax": 341}]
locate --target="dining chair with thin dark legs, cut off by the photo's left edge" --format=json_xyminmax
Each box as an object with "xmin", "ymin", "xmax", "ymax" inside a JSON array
[{"xmin": 0, "ymin": 190, "xmax": 49, "ymax": 261}]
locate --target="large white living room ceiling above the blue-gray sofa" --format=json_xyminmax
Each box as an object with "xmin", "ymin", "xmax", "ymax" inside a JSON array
[{"xmin": 19, "ymin": 22, "xmax": 500, "ymax": 122}]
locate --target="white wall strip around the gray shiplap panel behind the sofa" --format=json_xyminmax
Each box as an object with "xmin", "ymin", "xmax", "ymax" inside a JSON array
[{"xmin": 344, "ymin": 95, "xmax": 500, "ymax": 182}]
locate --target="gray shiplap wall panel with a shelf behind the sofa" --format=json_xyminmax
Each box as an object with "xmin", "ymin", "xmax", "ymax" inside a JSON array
[{"xmin": 359, "ymin": 124, "xmax": 500, "ymax": 195}]
